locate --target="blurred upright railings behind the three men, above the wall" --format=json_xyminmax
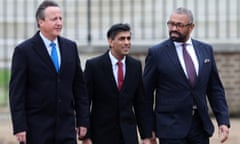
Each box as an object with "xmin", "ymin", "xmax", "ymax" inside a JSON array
[{"xmin": 0, "ymin": 0, "xmax": 240, "ymax": 105}]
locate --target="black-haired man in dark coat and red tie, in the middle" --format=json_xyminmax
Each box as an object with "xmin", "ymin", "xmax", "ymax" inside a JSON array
[{"xmin": 83, "ymin": 23, "xmax": 151, "ymax": 144}]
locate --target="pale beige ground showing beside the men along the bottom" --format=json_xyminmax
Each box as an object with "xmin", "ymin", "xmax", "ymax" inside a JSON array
[{"xmin": 0, "ymin": 113, "xmax": 240, "ymax": 144}]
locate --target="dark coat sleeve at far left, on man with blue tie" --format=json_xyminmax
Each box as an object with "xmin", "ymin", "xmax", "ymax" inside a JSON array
[{"xmin": 9, "ymin": 47, "xmax": 27, "ymax": 134}]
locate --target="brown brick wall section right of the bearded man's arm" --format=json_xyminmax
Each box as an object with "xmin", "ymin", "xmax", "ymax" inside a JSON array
[{"xmin": 215, "ymin": 52, "xmax": 240, "ymax": 116}]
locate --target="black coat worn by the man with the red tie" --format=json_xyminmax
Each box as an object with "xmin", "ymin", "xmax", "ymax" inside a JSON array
[{"xmin": 85, "ymin": 51, "xmax": 149, "ymax": 144}]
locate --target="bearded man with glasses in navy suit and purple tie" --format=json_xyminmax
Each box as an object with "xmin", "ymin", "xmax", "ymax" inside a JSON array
[{"xmin": 143, "ymin": 8, "xmax": 230, "ymax": 144}]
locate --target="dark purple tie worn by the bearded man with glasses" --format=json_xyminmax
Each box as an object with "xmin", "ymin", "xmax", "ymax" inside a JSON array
[{"xmin": 182, "ymin": 44, "xmax": 197, "ymax": 87}]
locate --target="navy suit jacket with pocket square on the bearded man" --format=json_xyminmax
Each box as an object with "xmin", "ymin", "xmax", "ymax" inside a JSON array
[{"xmin": 143, "ymin": 39, "xmax": 229, "ymax": 138}]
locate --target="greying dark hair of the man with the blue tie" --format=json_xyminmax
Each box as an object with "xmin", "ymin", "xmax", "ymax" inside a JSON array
[{"xmin": 35, "ymin": 0, "xmax": 59, "ymax": 27}]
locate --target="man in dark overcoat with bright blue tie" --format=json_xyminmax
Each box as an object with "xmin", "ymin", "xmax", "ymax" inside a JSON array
[{"xmin": 9, "ymin": 1, "xmax": 89, "ymax": 144}]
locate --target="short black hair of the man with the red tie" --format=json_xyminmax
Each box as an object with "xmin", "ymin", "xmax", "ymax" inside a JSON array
[{"xmin": 107, "ymin": 23, "xmax": 131, "ymax": 39}]
